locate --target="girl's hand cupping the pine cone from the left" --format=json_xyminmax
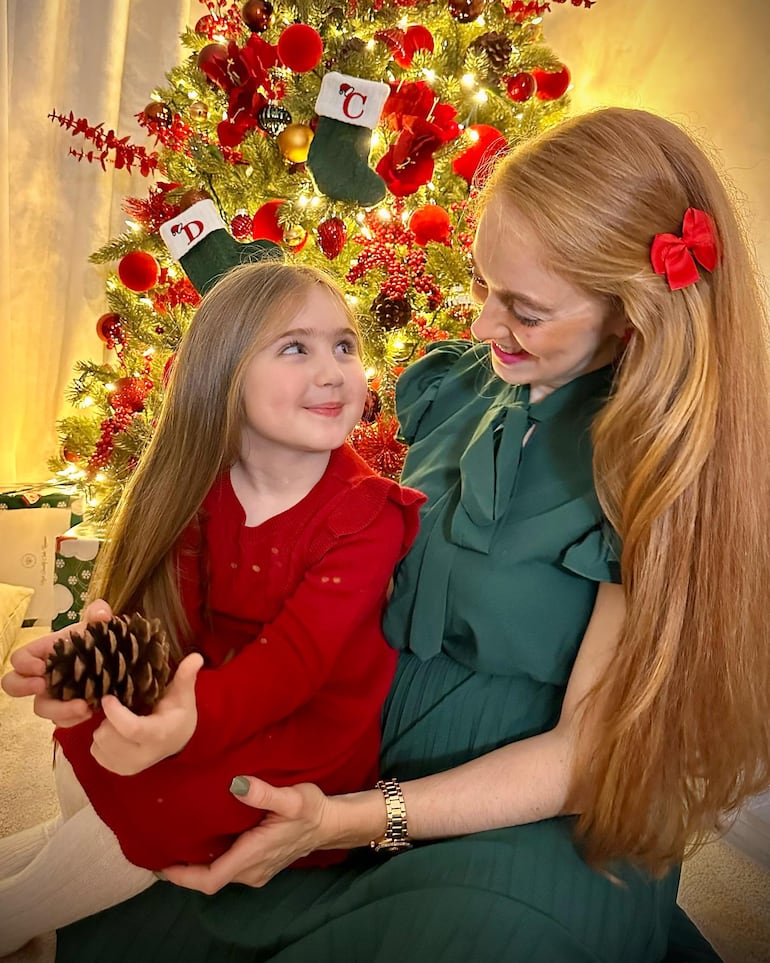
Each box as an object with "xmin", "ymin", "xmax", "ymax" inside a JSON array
[{"xmin": 0, "ymin": 599, "xmax": 112, "ymax": 727}]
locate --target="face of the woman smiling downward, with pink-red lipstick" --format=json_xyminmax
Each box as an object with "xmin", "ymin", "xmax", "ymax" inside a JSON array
[{"xmin": 471, "ymin": 199, "xmax": 626, "ymax": 401}]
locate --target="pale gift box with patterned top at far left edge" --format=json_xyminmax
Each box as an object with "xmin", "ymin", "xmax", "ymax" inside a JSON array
[{"xmin": 0, "ymin": 482, "xmax": 83, "ymax": 626}]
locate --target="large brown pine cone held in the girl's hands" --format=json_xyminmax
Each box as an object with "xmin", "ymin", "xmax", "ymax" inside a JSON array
[{"xmin": 46, "ymin": 614, "xmax": 169, "ymax": 712}]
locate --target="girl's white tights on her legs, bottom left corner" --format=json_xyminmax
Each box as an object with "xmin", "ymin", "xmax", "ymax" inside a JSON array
[{"xmin": 0, "ymin": 752, "xmax": 155, "ymax": 956}]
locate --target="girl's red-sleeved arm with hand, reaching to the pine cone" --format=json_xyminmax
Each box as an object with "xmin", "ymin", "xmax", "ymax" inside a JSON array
[{"xmin": 84, "ymin": 501, "xmax": 405, "ymax": 776}]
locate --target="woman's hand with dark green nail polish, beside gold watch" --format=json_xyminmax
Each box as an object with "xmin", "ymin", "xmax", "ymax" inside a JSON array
[{"xmin": 163, "ymin": 776, "xmax": 336, "ymax": 896}]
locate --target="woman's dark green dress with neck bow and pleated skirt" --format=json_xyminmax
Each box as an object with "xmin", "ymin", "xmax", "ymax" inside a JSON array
[{"xmin": 57, "ymin": 342, "xmax": 717, "ymax": 963}]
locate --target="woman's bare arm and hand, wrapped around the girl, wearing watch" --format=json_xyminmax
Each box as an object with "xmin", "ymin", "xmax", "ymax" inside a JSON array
[{"xmin": 166, "ymin": 584, "xmax": 625, "ymax": 893}]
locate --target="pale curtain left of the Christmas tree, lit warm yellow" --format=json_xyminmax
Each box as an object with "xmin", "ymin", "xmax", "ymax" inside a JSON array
[{"xmin": 0, "ymin": 0, "xmax": 195, "ymax": 483}]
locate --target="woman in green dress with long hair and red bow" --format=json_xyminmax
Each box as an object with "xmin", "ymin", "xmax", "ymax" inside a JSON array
[{"xmin": 6, "ymin": 109, "xmax": 770, "ymax": 963}]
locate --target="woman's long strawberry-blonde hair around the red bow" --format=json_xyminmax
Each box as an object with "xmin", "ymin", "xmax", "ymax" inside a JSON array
[{"xmin": 482, "ymin": 108, "xmax": 770, "ymax": 873}]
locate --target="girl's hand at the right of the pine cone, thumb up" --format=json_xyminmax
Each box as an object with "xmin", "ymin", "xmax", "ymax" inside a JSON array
[{"xmin": 91, "ymin": 653, "xmax": 203, "ymax": 776}]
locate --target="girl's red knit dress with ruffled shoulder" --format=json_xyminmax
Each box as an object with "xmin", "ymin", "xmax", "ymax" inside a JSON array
[{"xmin": 56, "ymin": 445, "xmax": 424, "ymax": 870}]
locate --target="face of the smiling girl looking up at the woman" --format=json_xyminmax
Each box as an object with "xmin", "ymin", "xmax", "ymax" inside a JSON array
[{"xmin": 243, "ymin": 284, "xmax": 366, "ymax": 456}]
